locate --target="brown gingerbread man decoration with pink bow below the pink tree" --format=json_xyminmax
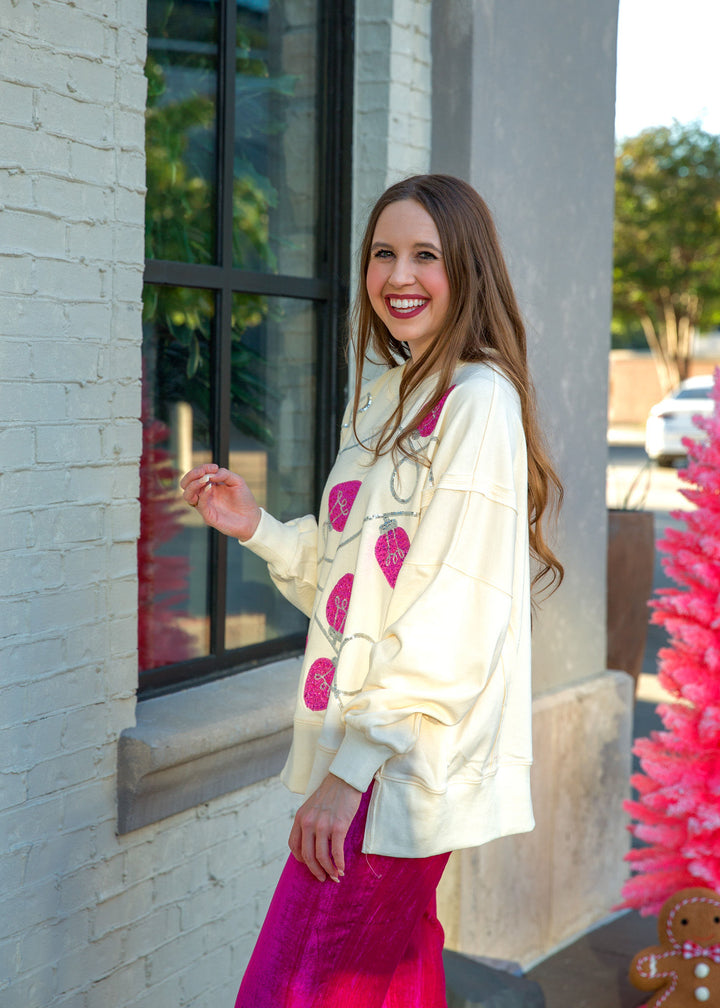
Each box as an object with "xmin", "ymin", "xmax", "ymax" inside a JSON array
[{"xmin": 630, "ymin": 888, "xmax": 720, "ymax": 1008}]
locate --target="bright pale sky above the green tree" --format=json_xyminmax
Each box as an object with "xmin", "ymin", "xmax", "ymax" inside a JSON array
[{"xmin": 615, "ymin": 0, "xmax": 720, "ymax": 139}]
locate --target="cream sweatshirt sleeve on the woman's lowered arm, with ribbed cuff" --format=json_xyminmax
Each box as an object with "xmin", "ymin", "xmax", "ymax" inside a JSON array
[{"xmin": 330, "ymin": 376, "xmax": 528, "ymax": 790}]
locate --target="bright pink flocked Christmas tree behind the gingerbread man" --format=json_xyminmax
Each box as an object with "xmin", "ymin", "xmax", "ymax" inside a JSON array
[{"xmin": 622, "ymin": 369, "xmax": 720, "ymax": 914}]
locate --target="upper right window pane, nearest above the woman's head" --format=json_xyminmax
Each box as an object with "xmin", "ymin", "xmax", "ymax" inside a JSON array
[{"xmin": 233, "ymin": 0, "xmax": 319, "ymax": 276}]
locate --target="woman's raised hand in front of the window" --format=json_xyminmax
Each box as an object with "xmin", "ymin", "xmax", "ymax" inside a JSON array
[{"xmin": 181, "ymin": 462, "xmax": 260, "ymax": 539}]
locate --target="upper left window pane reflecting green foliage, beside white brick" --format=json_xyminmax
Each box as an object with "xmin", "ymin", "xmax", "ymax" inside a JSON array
[{"xmin": 145, "ymin": 0, "xmax": 218, "ymax": 263}]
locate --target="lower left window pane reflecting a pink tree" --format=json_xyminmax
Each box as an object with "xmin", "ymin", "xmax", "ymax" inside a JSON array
[{"xmin": 138, "ymin": 285, "xmax": 215, "ymax": 670}]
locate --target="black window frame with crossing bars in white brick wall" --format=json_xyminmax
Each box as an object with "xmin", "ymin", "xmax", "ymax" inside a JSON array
[{"xmin": 138, "ymin": 0, "xmax": 355, "ymax": 699}]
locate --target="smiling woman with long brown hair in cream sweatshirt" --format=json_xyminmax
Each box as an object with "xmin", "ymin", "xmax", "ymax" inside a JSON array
[{"xmin": 182, "ymin": 175, "xmax": 563, "ymax": 1008}]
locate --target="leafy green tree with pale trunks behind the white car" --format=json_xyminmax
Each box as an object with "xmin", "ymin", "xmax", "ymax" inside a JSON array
[{"xmin": 613, "ymin": 123, "xmax": 720, "ymax": 385}]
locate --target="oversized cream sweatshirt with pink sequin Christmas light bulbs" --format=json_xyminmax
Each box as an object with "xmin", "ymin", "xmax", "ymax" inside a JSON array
[{"xmin": 243, "ymin": 364, "xmax": 533, "ymax": 857}]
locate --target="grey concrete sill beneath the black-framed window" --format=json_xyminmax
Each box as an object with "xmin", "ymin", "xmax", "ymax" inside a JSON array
[{"xmin": 117, "ymin": 658, "xmax": 302, "ymax": 834}]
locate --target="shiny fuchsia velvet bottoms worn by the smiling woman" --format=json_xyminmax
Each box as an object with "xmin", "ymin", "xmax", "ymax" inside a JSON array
[{"xmin": 235, "ymin": 791, "xmax": 450, "ymax": 1008}]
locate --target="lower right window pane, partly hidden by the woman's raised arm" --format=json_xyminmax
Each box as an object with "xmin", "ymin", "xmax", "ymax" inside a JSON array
[{"xmin": 225, "ymin": 294, "xmax": 317, "ymax": 648}]
